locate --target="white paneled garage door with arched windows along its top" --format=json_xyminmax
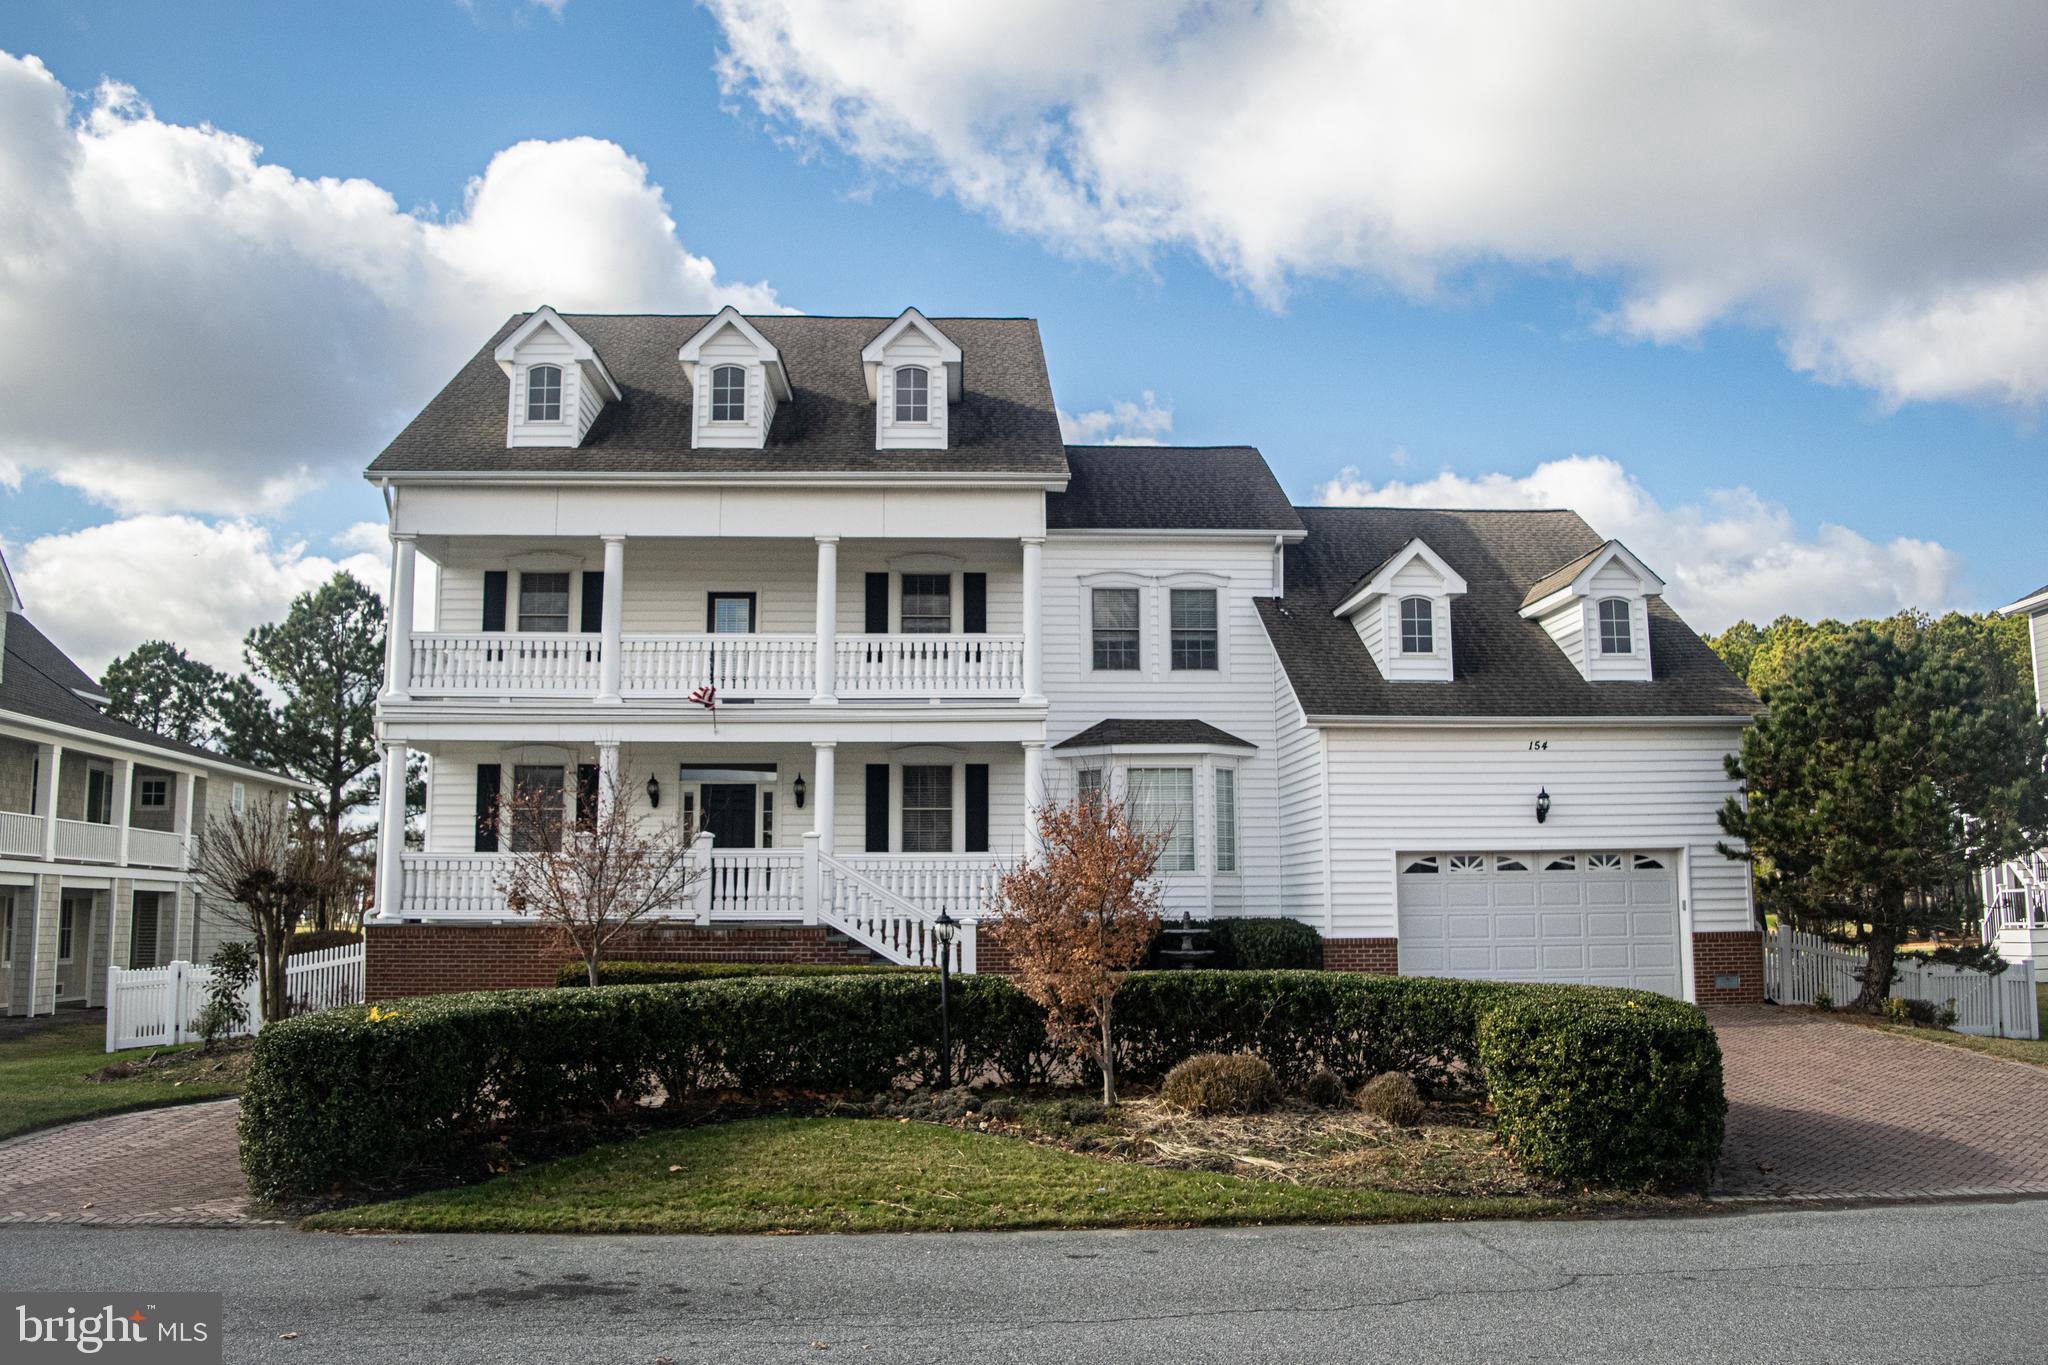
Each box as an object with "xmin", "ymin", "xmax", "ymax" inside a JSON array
[{"xmin": 1399, "ymin": 851, "xmax": 1683, "ymax": 997}]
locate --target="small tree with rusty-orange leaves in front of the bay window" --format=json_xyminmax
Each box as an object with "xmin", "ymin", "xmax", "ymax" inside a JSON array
[{"xmin": 985, "ymin": 794, "xmax": 1167, "ymax": 1105}]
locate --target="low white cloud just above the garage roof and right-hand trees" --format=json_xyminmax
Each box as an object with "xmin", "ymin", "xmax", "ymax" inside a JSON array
[{"xmin": 1317, "ymin": 454, "xmax": 1960, "ymax": 630}]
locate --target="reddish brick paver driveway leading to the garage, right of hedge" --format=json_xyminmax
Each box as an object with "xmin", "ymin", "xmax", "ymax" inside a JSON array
[{"xmin": 1712, "ymin": 1009, "xmax": 2048, "ymax": 1197}]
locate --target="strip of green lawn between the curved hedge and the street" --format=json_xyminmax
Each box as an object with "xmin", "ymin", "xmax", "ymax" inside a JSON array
[{"xmin": 307, "ymin": 1117, "xmax": 1571, "ymax": 1232}]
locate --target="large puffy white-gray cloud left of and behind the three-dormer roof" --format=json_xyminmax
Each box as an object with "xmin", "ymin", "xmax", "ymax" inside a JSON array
[{"xmin": 0, "ymin": 53, "xmax": 778, "ymax": 514}]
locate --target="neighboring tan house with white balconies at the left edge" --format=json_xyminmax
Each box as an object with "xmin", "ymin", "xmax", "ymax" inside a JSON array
[{"xmin": 0, "ymin": 559, "xmax": 293, "ymax": 1015}]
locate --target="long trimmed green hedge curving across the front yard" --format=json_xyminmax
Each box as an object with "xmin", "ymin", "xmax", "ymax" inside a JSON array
[{"xmin": 242, "ymin": 972, "xmax": 1726, "ymax": 1203}]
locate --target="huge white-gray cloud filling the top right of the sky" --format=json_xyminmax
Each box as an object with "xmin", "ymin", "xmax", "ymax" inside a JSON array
[{"xmin": 707, "ymin": 0, "xmax": 2048, "ymax": 405}]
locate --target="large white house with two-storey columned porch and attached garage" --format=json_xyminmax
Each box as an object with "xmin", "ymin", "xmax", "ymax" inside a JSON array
[{"xmin": 369, "ymin": 309, "xmax": 1761, "ymax": 1001}]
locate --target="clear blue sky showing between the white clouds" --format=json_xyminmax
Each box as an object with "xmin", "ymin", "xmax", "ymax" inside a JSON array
[{"xmin": 0, "ymin": 0, "xmax": 2048, "ymax": 671}]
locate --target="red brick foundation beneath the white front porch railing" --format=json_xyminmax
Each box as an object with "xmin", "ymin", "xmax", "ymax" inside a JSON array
[{"xmin": 362, "ymin": 923, "xmax": 874, "ymax": 1001}]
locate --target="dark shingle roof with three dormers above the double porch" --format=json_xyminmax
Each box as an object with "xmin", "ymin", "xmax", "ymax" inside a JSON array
[{"xmin": 369, "ymin": 313, "xmax": 1067, "ymax": 479}]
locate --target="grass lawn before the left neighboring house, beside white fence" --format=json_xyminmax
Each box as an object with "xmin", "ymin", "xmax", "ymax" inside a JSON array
[{"xmin": 0, "ymin": 1015, "xmax": 248, "ymax": 1138}]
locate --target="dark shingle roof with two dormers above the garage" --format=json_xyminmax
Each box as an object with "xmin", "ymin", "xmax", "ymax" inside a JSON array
[{"xmin": 1260, "ymin": 508, "xmax": 1761, "ymax": 720}]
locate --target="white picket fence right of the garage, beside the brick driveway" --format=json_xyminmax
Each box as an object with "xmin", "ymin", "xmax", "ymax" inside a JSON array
[{"xmin": 1765, "ymin": 927, "xmax": 2040, "ymax": 1038}]
